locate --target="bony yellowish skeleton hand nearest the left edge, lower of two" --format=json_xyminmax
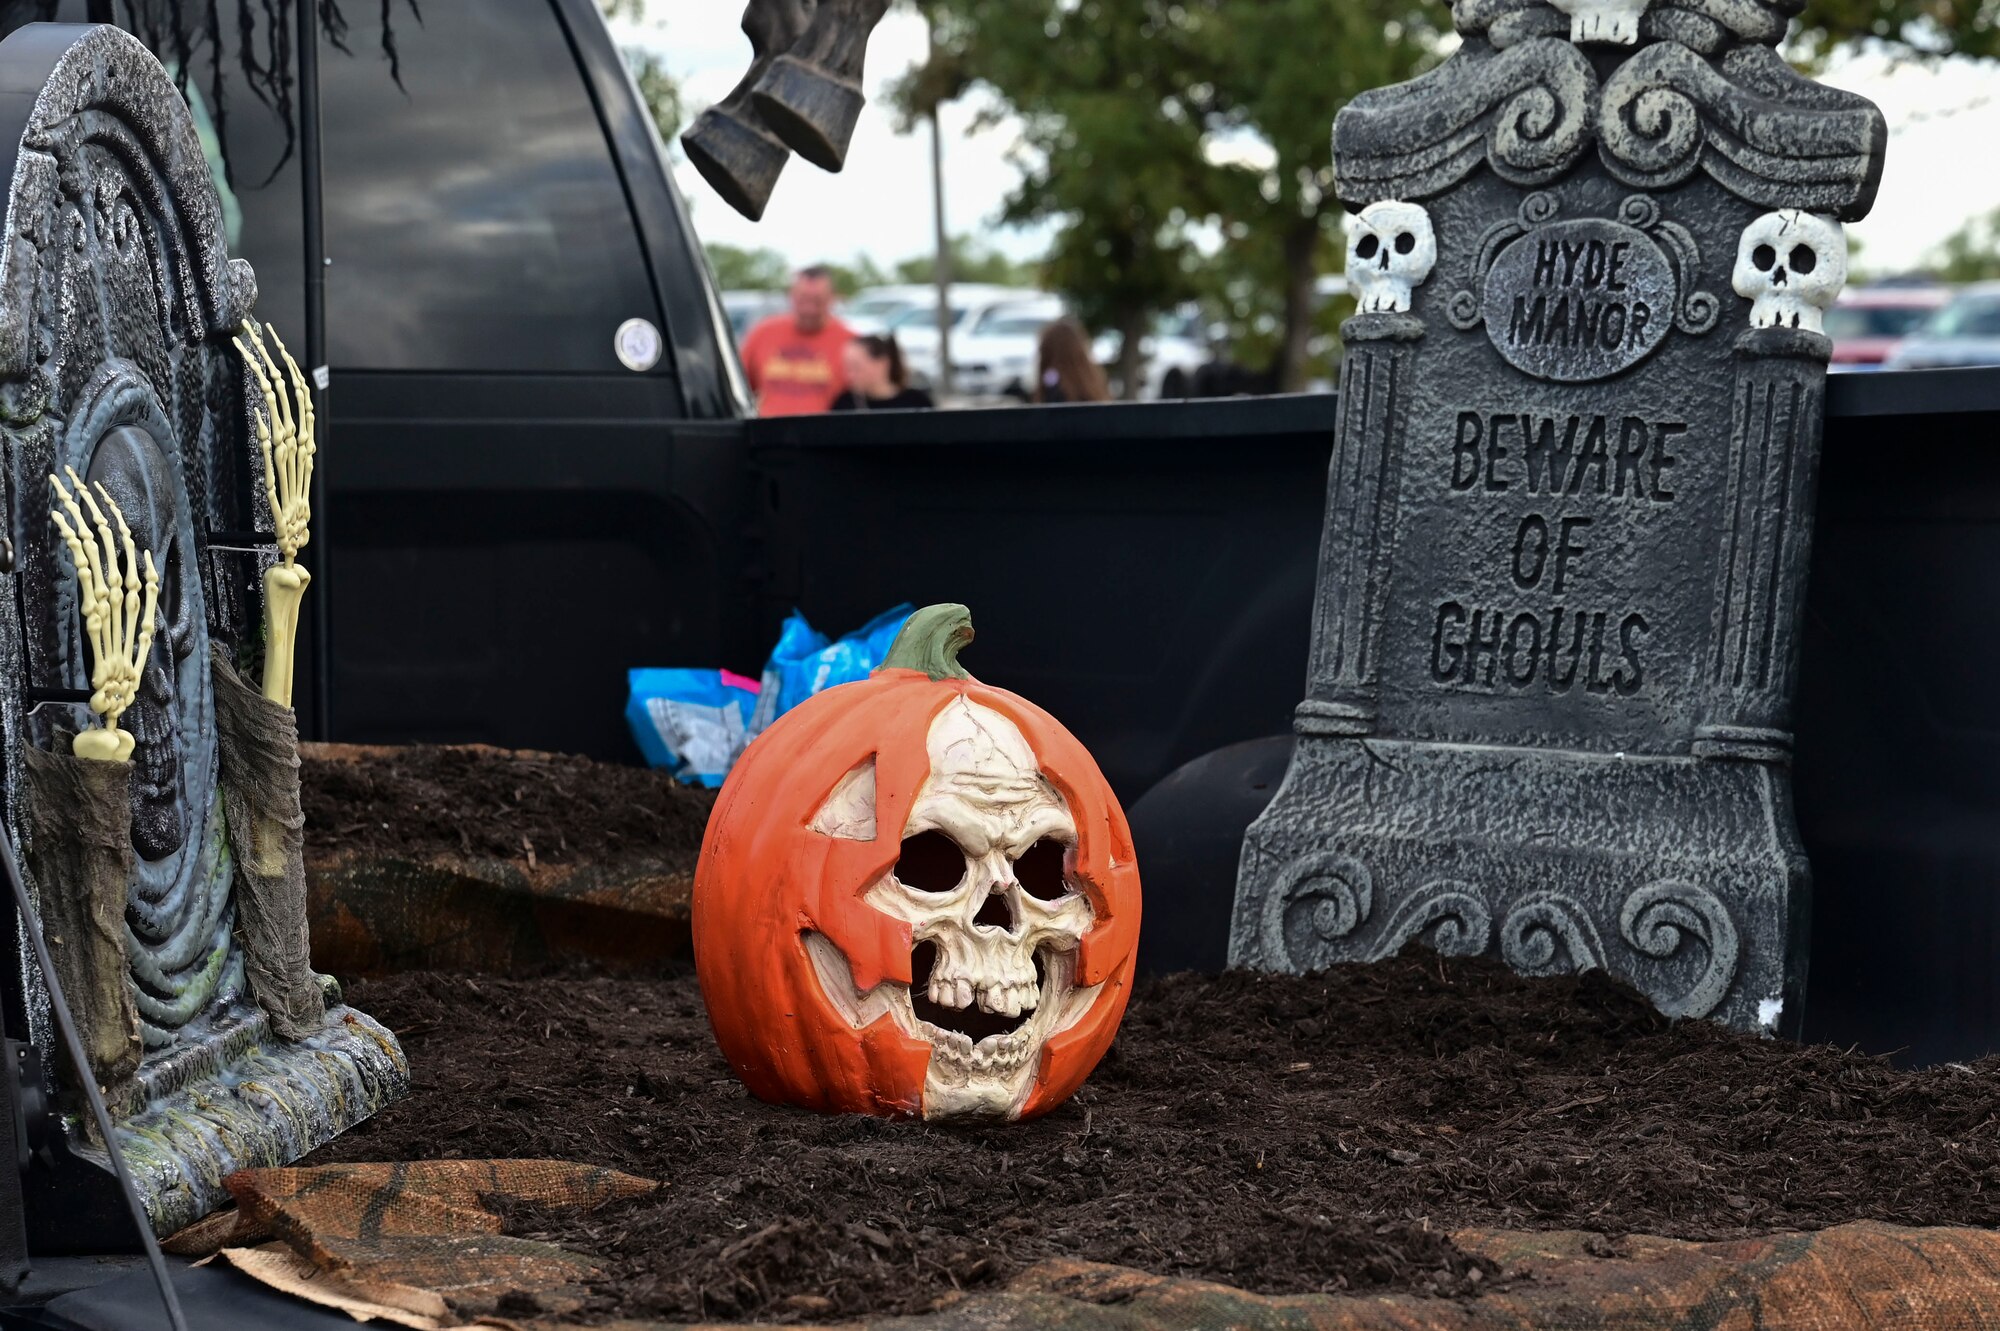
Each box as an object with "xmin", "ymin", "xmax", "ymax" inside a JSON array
[{"xmin": 48, "ymin": 468, "xmax": 160, "ymax": 761}]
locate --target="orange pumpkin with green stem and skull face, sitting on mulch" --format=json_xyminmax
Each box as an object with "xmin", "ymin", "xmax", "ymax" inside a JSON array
[{"xmin": 694, "ymin": 606, "xmax": 1140, "ymax": 1119}]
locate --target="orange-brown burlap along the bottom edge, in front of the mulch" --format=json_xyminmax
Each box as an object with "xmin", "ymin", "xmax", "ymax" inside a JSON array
[{"xmin": 168, "ymin": 1161, "xmax": 2000, "ymax": 1331}]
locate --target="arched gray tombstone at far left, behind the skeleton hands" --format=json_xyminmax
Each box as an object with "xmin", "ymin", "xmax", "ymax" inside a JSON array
[{"xmin": 0, "ymin": 24, "xmax": 408, "ymax": 1249}]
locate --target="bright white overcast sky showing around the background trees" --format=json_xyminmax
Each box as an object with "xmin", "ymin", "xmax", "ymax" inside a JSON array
[{"xmin": 616, "ymin": 10, "xmax": 2000, "ymax": 281}]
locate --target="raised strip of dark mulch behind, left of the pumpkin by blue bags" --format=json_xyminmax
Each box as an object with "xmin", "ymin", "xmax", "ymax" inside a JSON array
[{"xmin": 300, "ymin": 745, "xmax": 716, "ymax": 877}]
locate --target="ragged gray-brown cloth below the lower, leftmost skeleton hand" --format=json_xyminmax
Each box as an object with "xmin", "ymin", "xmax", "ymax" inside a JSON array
[{"xmin": 22, "ymin": 735, "xmax": 144, "ymax": 1091}]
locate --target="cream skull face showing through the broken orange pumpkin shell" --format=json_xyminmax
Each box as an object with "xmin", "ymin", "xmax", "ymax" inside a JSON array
[{"xmin": 806, "ymin": 697, "xmax": 1098, "ymax": 1119}]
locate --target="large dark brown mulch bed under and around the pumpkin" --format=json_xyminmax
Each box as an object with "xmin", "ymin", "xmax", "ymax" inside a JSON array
[{"xmin": 300, "ymin": 953, "xmax": 2000, "ymax": 1319}]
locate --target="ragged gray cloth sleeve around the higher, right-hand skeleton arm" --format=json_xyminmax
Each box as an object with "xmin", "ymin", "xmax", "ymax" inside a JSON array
[{"xmin": 212, "ymin": 652, "xmax": 326, "ymax": 1039}]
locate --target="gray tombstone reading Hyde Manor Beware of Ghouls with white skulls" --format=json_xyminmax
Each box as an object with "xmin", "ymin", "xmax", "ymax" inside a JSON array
[{"xmin": 1230, "ymin": 0, "xmax": 1886, "ymax": 1031}]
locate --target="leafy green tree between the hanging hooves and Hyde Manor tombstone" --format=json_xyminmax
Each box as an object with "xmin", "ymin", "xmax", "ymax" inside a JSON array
[{"xmin": 916, "ymin": 0, "xmax": 1448, "ymax": 386}]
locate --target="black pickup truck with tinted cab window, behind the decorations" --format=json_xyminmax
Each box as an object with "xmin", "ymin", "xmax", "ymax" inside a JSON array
[{"xmin": 28, "ymin": 0, "xmax": 2000, "ymax": 1061}]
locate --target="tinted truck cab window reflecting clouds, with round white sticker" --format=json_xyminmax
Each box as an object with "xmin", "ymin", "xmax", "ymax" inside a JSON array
[{"xmin": 320, "ymin": 0, "xmax": 660, "ymax": 374}]
